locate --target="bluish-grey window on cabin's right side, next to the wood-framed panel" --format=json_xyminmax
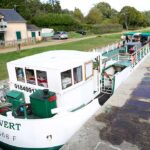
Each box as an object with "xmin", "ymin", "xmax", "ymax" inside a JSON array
[{"xmin": 73, "ymin": 66, "xmax": 82, "ymax": 84}]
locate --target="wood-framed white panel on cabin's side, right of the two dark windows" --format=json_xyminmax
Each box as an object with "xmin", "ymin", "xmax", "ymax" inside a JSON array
[{"xmin": 85, "ymin": 61, "xmax": 93, "ymax": 79}]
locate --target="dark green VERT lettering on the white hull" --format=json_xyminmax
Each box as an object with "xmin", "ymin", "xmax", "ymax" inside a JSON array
[{"xmin": 0, "ymin": 120, "xmax": 21, "ymax": 131}]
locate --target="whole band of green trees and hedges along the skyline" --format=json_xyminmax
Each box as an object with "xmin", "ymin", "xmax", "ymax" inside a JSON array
[{"xmin": 0, "ymin": 0, "xmax": 150, "ymax": 31}]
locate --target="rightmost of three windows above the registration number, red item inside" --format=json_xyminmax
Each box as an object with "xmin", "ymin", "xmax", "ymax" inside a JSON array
[{"xmin": 36, "ymin": 70, "xmax": 48, "ymax": 88}]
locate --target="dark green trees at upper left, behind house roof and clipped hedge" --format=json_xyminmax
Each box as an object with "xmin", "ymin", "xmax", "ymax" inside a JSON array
[{"xmin": 0, "ymin": 0, "xmax": 61, "ymax": 22}]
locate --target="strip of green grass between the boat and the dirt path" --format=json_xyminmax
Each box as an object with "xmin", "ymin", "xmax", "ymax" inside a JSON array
[{"xmin": 0, "ymin": 34, "xmax": 120, "ymax": 80}]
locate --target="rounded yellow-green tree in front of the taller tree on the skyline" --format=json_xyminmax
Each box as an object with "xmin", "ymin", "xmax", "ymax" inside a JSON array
[{"xmin": 86, "ymin": 7, "xmax": 102, "ymax": 24}]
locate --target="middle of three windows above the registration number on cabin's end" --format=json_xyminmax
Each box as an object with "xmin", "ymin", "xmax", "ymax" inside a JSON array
[{"xmin": 25, "ymin": 69, "xmax": 35, "ymax": 85}]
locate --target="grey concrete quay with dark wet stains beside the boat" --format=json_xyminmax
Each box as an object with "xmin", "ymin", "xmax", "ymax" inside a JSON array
[{"xmin": 61, "ymin": 55, "xmax": 150, "ymax": 150}]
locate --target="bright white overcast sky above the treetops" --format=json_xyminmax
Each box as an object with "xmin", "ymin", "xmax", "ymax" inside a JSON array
[{"xmin": 41, "ymin": 0, "xmax": 150, "ymax": 15}]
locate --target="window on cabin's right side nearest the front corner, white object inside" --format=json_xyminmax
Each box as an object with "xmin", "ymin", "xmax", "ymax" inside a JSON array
[{"xmin": 61, "ymin": 70, "xmax": 72, "ymax": 89}]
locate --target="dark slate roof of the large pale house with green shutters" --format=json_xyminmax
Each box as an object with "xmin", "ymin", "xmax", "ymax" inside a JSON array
[{"xmin": 0, "ymin": 9, "xmax": 26, "ymax": 23}]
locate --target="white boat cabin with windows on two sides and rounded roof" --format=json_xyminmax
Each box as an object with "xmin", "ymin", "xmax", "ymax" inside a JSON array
[{"xmin": 7, "ymin": 50, "xmax": 100, "ymax": 110}]
